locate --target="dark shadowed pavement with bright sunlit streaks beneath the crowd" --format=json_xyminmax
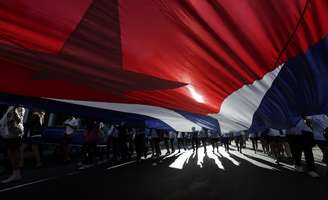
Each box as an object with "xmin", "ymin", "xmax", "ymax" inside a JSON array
[{"xmin": 0, "ymin": 144, "xmax": 328, "ymax": 200}]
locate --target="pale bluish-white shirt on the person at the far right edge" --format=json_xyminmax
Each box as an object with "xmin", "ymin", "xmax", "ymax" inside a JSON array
[{"xmin": 307, "ymin": 115, "xmax": 328, "ymax": 141}]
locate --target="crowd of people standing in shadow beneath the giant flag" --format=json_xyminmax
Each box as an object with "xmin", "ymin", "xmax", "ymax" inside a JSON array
[{"xmin": 0, "ymin": 106, "xmax": 328, "ymax": 183}]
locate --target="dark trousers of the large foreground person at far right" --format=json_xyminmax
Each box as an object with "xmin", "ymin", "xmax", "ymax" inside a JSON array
[{"xmin": 287, "ymin": 133, "xmax": 315, "ymax": 171}]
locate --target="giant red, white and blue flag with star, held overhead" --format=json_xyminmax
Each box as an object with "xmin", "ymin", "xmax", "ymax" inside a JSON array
[{"xmin": 0, "ymin": 0, "xmax": 328, "ymax": 132}]
